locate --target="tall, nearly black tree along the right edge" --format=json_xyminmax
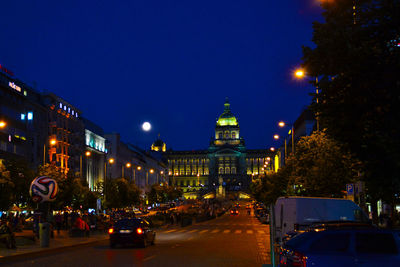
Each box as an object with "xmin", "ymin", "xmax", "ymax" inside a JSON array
[{"xmin": 303, "ymin": 0, "xmax": 400, "ymax": 216}]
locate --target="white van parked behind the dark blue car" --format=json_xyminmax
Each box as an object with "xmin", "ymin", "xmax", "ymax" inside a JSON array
[{"xmin": 275, "ymin": 197, "xmax": 368, "ymax": 241}]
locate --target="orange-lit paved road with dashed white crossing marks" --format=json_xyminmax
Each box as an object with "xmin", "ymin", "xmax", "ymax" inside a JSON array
[{"xmin": 9, "ymin": 209, "xmax": 269, "ymax": 267}]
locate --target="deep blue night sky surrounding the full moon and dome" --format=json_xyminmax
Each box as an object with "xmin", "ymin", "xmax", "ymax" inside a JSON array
[{"xmin": 0, "ymin": 0, "xmax": 321, "ymax": 150}]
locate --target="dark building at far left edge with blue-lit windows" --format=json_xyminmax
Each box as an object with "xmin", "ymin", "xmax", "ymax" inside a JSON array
[{"xmin": 0, "ymin": 70, "xmax": 48, "ymax": 169}]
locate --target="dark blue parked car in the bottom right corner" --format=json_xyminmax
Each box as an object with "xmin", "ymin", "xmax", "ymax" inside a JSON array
[{"xmin": 279, "ymin": 225, "xmax": 400, "ymax": 267}]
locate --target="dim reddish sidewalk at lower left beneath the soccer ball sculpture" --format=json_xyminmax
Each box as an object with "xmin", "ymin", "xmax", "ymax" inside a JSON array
[{"xmin": 0, "ymin": 230, "xmax": 108, "ymax": 264}]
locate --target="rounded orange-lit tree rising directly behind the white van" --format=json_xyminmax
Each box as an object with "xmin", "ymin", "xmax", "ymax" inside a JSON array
[{"xmin": 282, "ymin": 131, "xmax": 358, "ymax": 197}]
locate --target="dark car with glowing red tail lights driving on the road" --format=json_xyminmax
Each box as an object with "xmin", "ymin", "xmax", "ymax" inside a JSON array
[{"xmin": 108, "ymin": 218, "xmax": 156, "ymax": 248}]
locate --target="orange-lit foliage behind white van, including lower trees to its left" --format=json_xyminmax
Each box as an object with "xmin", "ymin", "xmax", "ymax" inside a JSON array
[{"xmin": 251, "ymin": 132, "xmax": 359, "ymax": 203}]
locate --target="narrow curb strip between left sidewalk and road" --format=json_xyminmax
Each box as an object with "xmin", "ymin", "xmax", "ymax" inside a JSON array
[{"xmin": 0, "ymin": 237, "xmax": 108, "ymax": 265}]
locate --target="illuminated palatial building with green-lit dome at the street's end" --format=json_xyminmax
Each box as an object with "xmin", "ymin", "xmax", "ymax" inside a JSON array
[{"xmin": 165, "ymin": 100, "xmax": 274, "ymax": 197}]
